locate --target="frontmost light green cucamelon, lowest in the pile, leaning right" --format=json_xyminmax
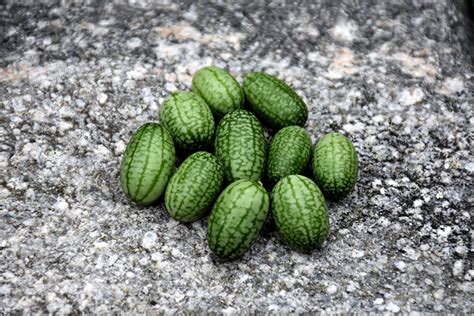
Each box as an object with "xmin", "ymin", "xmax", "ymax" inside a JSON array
[{"xmin": 207, "ymin": 180, "xmax": 270, "ymax": 259}]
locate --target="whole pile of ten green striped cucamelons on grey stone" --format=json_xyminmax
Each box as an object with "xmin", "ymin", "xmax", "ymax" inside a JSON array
[{"xmin": 120, "ymin": 67, "xmax": 358, "ymax": 259}]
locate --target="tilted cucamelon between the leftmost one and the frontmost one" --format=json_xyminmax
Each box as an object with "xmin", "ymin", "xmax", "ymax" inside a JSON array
[{"xmin": 165, "ymin": 151, "xmax": 224, "ymax": 223}]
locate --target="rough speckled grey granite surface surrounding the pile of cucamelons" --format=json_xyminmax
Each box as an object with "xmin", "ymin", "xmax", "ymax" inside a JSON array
[{"xmin": 0, "ymin": 0, "xmax": 474, "ymax": 313}]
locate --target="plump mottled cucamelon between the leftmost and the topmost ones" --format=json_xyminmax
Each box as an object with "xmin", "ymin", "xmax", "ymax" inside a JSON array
[{"xmin": 160, "ymin": 92, "xmax": 215, "ymax": 151}]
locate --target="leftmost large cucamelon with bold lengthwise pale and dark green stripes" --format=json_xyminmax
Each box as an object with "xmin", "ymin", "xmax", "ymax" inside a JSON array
[{"xmin": 120, "ymin": 123, "xmax": 176, "ymax": 205}]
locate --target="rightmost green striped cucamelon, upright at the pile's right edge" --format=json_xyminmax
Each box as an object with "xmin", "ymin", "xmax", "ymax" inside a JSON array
[{"xmin": 312, "ymin": 133, "xmax": 359, "ymax": 201}]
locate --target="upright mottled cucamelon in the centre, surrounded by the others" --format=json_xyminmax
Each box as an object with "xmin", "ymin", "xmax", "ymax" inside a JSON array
[{"xmin": 214, "ymin": 110, "xmax": 266, "ymax": 182}]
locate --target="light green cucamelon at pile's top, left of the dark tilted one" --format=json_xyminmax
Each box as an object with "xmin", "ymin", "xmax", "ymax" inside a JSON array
[{"xmin": 193, "ymin": 66, "xmax": 245, "ymax": 117}]
